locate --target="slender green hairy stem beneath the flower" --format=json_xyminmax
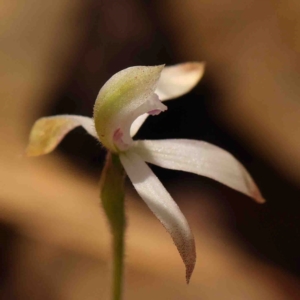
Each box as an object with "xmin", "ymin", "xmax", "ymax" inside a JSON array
[{"xmin": 100, "ymin": 153, "xmax": 126, "ymax": 300}]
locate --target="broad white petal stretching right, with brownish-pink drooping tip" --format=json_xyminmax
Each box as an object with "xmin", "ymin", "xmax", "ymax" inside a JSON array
[{"xmin": 133, "ymin": 139, "xmax": 265, "ymax": 203}]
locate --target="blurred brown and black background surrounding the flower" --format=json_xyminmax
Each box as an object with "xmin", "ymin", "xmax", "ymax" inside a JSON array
[{"xmin": 0, "ymin": 0, "xmax": 300, "ymax": 300}]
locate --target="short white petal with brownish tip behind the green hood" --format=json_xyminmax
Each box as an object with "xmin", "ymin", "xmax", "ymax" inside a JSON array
[{"xmin": 155, "ymin": 62, "xmax": 205, "ymax": 101}]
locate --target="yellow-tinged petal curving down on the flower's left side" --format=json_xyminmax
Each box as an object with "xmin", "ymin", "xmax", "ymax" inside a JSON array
[{"xmin": 26, "ymin": 115, "xmax": 98, "ymax": 156}]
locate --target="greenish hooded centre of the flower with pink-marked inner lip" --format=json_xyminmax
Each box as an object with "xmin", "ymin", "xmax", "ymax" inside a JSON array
[{"xmin": 94, "ymin": 65, "xmax": 167, "ymax": 152}]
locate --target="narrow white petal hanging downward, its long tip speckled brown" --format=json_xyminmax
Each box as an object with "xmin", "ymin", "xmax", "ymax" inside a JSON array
[{"xmin": 120, "ymin": 151, "xmax": 196, "ymax": 282}]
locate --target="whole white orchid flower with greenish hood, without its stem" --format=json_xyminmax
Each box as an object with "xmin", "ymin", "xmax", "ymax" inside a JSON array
[{"xmin": 27, "ymin": 63, "xmax": 264, "ymax": 290}]
